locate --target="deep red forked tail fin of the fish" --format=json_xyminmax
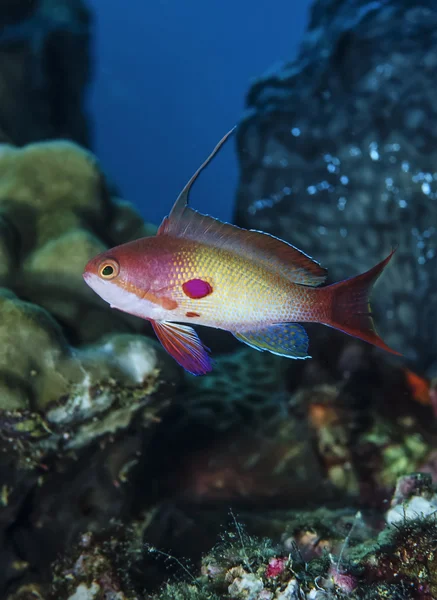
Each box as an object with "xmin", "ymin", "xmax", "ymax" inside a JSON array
[{"xmin": 319, "ymin": 249, "xmax": 400, "ymax": 355}]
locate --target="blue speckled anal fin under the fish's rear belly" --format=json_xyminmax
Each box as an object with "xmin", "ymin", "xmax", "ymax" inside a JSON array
[{"xmin": 233, "ymin": 323, "xmax": 311, "ymax": 358}]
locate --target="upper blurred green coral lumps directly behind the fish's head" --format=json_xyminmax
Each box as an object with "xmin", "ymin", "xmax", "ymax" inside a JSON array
[{"xmin": 0, "ymin": 141, "xmax": 157, "ymax": 342}]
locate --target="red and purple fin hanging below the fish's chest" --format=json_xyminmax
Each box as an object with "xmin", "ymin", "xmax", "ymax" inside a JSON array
[{"xmin": 151, "ymin": 321, "xmax": 212, "ymax": 375}]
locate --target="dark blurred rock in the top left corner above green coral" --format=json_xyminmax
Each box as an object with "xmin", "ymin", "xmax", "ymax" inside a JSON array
[{"xmin": 0, "ymin": 0, "xmax": 91, "ymax": 146}]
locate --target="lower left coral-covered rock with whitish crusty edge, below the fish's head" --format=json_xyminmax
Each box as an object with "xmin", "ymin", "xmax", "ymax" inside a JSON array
[{"xmin": 0, "ymin": 291, "xmax": 178, "ymax": 586}]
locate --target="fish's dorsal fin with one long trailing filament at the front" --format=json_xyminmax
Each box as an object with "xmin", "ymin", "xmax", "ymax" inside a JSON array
[{"xmin": 157, "ymin": 127, "xmax": 327, "ymax": 286}]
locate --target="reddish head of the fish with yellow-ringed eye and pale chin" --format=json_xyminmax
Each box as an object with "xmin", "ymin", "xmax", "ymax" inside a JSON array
[{"xmin": 83, "ymin": 238, "xmax": 170, "ymax": 319}]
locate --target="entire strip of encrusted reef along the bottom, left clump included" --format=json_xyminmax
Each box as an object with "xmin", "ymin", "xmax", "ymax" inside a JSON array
[{"xmin": 27, "ymin": 474, "xmax": 437, "ymax": 600}]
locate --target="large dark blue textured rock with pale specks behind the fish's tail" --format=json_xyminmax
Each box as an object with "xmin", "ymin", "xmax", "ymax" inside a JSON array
[{"xmin": 236, "ymin": 0, "xmax": 437, "ymax": 375}]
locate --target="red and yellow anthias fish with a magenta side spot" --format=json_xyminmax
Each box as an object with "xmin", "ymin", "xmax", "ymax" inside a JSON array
[{"xmin": 84, "ymin": 130, "xmax": 398, "ymax": 375}]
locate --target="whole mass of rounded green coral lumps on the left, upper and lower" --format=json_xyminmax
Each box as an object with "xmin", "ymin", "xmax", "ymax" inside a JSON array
[{"xmin": 0, "ymin": 141, "xmax": 181, "ymax": 588}]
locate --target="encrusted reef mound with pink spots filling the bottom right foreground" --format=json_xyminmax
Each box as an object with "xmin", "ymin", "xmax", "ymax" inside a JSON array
[{"xmin": 147, "ymin": 482, "xmax": 437, "ymax": 600}]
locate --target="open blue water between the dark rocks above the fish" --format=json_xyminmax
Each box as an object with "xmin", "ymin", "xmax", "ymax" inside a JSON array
[{"xmin": 89, "ymin": 0, "xmax": 309, "ymax": 223}]
